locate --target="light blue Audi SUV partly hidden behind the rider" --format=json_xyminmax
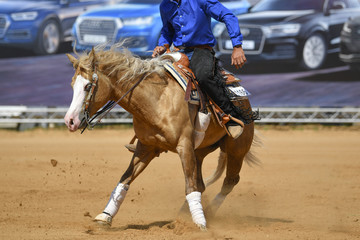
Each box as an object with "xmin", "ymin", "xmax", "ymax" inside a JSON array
[{"xmin": 73, "ymin": 0, "xmax": 251, "ymax": 57}]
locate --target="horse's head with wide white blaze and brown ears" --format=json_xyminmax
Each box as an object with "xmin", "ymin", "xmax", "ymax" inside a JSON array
[{"xmin": 64, "ymin": 49, "xmax": 111, "ymax": 132}]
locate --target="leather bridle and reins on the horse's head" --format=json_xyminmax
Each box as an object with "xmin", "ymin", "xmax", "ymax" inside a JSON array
[{"xmin": 80, "ymin": 66, "xmax": 149, "ymax": 134}]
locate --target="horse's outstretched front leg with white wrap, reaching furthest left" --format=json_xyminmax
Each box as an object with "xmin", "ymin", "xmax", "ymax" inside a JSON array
[{"xmin": 95, "ymin": 142, "xmax": 160, "ymax": 226}]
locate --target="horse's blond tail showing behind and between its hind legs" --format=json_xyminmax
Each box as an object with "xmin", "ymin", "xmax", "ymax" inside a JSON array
[{"xmin": 205, "ymin": 130, "xmax": 263, "ymax": 187}]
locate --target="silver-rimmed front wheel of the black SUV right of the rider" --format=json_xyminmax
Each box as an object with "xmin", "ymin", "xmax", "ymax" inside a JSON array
[{"xmin": 301, "ymin": 33, "xmax": 327, "ymax": 70}]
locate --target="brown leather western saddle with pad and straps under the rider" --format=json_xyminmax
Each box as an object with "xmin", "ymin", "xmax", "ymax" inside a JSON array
[{"xmin": 164, "ymin": 52, "xmax": 250, "ymax": 136}]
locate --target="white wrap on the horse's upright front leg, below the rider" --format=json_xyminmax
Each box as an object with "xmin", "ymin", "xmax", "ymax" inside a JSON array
[{"xmin": 186, "ymin": 192, "xmax": 206, "ymax": 228}]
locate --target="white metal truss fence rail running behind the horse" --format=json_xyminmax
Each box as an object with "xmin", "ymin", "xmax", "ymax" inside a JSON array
[{"xmin": 0, "ymin": 106, "xmax": 360, "ymax": 127}]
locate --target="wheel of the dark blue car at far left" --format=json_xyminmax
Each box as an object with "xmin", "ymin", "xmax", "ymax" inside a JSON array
[{"xmin": 35, "ymin": 20, "xmax": 60, "ymax": 55}]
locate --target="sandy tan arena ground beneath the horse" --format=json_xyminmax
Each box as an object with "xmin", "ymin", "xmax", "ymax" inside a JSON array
[{"xmin": 0, "ymin": 126, "xmax": 360, "ymax": 240}]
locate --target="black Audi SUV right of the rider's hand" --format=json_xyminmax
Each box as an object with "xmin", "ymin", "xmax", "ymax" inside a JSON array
[{"xmin": 218, "ymin": 0, "xmax": 360, "ymax": 70}]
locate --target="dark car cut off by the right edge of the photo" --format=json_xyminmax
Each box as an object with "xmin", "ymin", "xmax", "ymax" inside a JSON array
[{"xmin": 339, "ymin": 17, "xmax": 360, "ymax": 73}]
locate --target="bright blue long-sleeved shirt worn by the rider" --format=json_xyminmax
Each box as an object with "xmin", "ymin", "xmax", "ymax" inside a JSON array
[{"xmin": 159, "ymin": 0, "xmax": 242, "ymax": 47}]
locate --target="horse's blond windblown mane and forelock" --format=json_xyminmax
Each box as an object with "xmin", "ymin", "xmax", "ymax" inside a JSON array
[{"xmin": 76, "ymin": 43, "xmax": 171, "ymax": 84}]
